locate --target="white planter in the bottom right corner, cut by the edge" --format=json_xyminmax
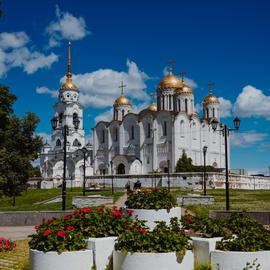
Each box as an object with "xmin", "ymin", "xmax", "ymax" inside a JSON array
[{"xmin": 210, "ymin": 250, "xmax": 270, "ymax": 270}]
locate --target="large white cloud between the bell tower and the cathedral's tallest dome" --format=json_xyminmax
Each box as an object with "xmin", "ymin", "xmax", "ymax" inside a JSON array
[{"xmin": 65, "ymin": 60, "xmax": 150, "ymax": 108}]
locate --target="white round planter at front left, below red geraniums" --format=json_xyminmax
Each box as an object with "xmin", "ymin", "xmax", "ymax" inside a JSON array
[{"xmin": 30, "ymin": 249, "xmax": 93, "ymax": 270}]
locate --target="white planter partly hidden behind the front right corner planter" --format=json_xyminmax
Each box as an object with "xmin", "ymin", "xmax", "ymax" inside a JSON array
[{"xmin": 191, "ymin": 237, "xmax": 222, "ymax": 264}]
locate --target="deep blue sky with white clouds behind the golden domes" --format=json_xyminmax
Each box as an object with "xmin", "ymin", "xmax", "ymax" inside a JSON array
[{"xmin": 0, "ymin": 0, "xmax": 270, "ymax": 173}]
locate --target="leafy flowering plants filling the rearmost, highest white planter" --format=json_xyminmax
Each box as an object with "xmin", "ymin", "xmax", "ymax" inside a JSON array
[{"xmin": 125, "ymin": 188, "xmax": 176, "ymax": 209}]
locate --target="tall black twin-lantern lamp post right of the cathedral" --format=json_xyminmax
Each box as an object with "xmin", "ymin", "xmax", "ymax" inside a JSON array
[{"xmin": 211, "ymin": 117, "xmax": 240, "ymax": 211}]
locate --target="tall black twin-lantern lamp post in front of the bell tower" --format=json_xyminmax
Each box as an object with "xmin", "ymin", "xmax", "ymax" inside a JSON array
[{"xmin": 51, "ymin": 117, "xmax": 80, "ymax": 211}]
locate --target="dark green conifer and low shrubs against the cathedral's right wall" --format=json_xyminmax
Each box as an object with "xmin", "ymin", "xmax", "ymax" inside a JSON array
[{"xmin": 175, "ymin": 151, "xmax": 216, "ymax": 172}]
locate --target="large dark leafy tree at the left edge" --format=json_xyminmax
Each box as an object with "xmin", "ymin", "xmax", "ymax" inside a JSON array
[{"xmin": 0, "ymin": 86, "xmax": 42, "ymax": 204}]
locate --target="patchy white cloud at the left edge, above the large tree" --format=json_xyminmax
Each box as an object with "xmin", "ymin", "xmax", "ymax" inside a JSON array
[{"xmin": 0, "ymin": 32, "xmax": 58, "ymax": 77}]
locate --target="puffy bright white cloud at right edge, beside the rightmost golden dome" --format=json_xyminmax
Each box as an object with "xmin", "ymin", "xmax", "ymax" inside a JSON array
[{"xmin": 234, "ymin": 85, "xmax": 270, "ymax": 120}]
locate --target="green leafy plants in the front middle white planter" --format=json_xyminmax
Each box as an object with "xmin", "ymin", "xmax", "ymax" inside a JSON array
[{"xmin": 115, "ymin": 218, "xmax": 191, "ymax": 255}]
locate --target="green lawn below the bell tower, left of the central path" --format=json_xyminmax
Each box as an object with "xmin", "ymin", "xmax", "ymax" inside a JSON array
[{"xmin": 0, "ymin": 188, "xmax": 124, "ymax": 211}]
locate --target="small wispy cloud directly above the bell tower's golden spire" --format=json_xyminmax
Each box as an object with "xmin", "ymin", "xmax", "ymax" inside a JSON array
[{"xmin": 45, "ymin": 5, "xmax": 89, "ymax": 47}]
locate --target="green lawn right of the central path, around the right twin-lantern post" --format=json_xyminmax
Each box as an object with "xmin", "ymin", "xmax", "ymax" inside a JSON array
[{"xmin": 172, "ymin": 189, "xmax": 270, "ymax": 211}]
